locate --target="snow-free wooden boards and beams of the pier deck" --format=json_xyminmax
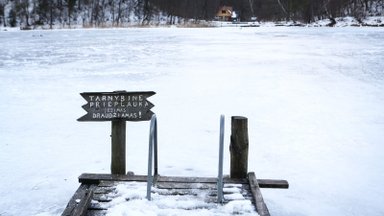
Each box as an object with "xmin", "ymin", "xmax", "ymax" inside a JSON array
[{"xmin": 62, "ymin": 172, "xmax": 289, "ymax": 216}]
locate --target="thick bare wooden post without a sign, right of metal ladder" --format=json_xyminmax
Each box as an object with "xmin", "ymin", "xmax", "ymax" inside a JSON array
[{"xmin": 229, "ymin": 116, "xmax": 249, "ymax": 178}]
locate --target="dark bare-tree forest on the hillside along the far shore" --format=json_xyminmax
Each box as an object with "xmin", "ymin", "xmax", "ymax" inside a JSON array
[{"xmin": 0, "ymin": 0, "xmax": 384, "ymax": 28}]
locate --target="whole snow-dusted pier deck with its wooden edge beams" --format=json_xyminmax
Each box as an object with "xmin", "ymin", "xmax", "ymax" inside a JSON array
[{"xmin": 62, "ymin": 173, "xmax": 288, "ymax": 216}]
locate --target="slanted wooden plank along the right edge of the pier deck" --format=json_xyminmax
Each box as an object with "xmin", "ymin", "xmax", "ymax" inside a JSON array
[{"xmin": 248, "ymin": 172, "xmax": 270, "ymax": 216}]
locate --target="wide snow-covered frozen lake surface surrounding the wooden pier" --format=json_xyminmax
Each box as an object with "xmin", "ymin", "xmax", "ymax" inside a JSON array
[{"xmin": 0, "ymin": 27, "xmax": 384, "ymax": 216}]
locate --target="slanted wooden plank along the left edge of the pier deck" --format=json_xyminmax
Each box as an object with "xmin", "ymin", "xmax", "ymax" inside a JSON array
[{"xmin": 62, "ymin": 184, "xmax": 96, "ymax": 216}]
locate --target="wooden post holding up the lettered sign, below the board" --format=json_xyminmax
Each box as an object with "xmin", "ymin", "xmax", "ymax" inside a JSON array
[{"xmin": 111, "ymin": 120, "xmax": 126, "ymax": 175}]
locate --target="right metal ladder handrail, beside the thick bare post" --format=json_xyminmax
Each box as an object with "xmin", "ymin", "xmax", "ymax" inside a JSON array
[{"xmin": 217, "ymin": 115, "xmax": 225, "ymax": 203}]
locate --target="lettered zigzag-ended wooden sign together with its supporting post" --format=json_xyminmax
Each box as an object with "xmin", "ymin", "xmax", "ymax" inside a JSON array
[{"xmin": 77, "ymin": 91, "xmax": 156, "ymax": 175}]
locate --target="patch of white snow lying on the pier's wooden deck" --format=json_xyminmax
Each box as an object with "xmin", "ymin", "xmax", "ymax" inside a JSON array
[{"xmin": 100, "ymin": 182, "xmax": 258, "ymax": 216}]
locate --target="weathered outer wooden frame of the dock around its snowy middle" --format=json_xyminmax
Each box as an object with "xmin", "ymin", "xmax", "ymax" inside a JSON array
[{"xmin": 62, "ymin": 172, "xmax": 289, "ymax": 216}]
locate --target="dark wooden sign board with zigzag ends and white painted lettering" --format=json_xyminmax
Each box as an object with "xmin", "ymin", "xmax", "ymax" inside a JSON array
[{"xmin": 77, "ymin": 91, "xmax": 156, "ymax": 121}]
